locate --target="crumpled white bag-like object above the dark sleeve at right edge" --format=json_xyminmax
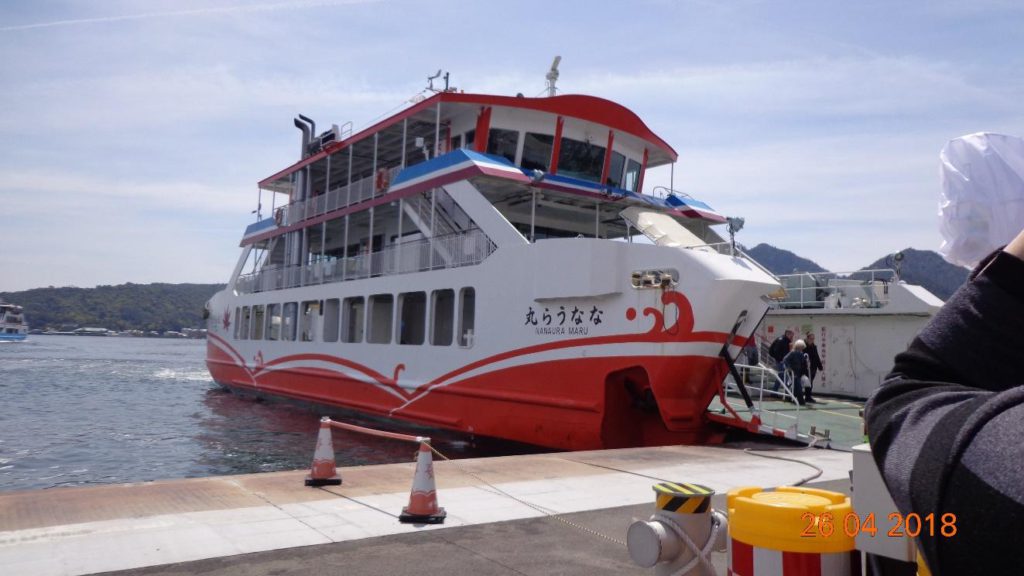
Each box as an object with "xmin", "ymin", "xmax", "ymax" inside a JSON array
[{"xmin": 939, "ymin": 132, "xmax": 1024, "ymax": 266}]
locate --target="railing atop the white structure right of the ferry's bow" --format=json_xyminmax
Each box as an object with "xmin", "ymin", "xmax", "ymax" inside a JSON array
[{"xmin": 777, "ymin": 269, "xmax": 899, "ymax": 310}]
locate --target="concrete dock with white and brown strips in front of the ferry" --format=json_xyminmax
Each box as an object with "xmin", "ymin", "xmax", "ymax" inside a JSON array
[{"xmin": 0, "ymin": 438, "xmax": 851, "ymax": 576}]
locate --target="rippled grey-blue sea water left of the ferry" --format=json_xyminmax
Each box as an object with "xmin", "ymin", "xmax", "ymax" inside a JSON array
[{"xmin": 0, "ymin": 336, "xmax": 538, "ymax": 490}]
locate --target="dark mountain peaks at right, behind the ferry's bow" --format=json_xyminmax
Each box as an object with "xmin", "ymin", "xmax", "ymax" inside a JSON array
[{"xmin": 746, "ymin": 244, "xmax": 969, "ymax": 300}]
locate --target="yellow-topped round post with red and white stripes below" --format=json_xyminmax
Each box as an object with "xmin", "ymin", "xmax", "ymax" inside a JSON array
[{"xmin": 728, "ymin": 487, "xmax": 861, "ymax": 576}]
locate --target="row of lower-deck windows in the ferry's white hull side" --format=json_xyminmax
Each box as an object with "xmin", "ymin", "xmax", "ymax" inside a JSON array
[{"xmin": 234, "ymin": 288, "xmax": 476, "ymax": 347}]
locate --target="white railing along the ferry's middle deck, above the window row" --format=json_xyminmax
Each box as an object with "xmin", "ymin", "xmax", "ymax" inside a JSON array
[{"xmin": 234, "ymin": 229, "xmax": 497, "ymax": 293}]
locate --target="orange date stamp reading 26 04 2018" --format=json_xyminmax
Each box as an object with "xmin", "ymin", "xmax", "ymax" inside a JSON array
[{"xmin": 800, "ymin": 512, "xmax": 956, "ymax": 538}]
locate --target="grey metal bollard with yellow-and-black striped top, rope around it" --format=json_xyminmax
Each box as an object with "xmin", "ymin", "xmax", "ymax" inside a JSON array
[{"xmin": 626, "ymin": 482, "xmax": 726, "ymax": 576}]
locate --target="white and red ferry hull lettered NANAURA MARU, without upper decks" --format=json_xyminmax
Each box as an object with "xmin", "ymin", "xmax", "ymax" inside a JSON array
[{"xmin": 207, "ymin": 239, "xmax": 777, "ymax": 450}]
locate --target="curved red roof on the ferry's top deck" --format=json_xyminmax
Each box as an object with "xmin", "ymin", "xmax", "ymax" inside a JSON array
[{"xmin": 259, "ymin": 92, "xmax": 678, "ymax": 187}]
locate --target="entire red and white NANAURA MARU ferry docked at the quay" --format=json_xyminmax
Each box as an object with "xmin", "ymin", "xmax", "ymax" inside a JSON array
[{"xmin": 207, "ymin": 73, "xmax": 779, "ymax": 450}]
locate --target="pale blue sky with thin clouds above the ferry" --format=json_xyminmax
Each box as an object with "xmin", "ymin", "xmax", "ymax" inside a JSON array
[{"xmin": 0, "ymin": 0, "xmax": 1024, "ymax": 291}]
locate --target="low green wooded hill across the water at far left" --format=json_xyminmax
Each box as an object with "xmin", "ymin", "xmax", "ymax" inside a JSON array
[{"xmin": 0, "ymin": 284, "xmax": 224, "ymax": 332}]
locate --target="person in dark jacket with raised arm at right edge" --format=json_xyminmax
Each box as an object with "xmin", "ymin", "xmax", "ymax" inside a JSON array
[{"xmin": 864, "ymin": 232, "xmax": 1024, "ymax": 576}]
